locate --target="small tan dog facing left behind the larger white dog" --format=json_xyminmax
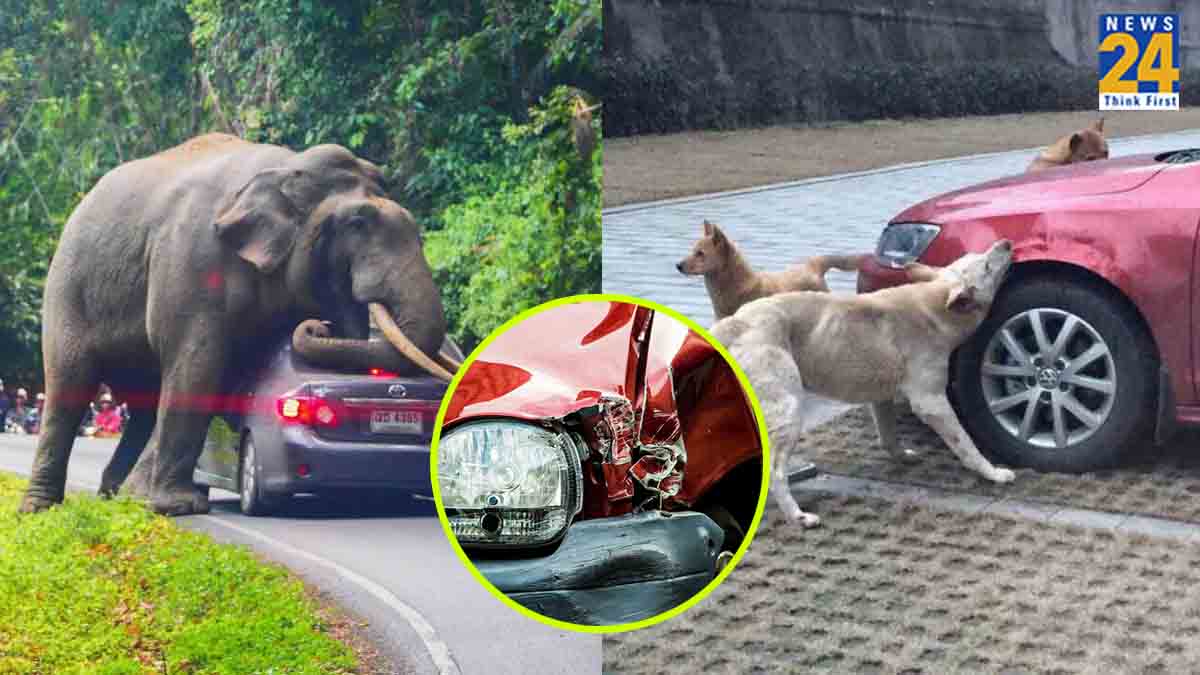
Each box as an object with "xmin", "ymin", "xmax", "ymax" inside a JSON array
[{"xmin": 676, "ymin": 220, "xmax": 864, "ymax": 319}]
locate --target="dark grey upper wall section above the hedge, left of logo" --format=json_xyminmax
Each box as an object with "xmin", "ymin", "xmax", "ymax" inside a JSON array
[{"xmin": 605, "ymin": 0, "xmax": 1054, "ymax": 76}]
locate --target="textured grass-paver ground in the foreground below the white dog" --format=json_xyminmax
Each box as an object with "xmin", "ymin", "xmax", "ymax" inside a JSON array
[{"xmin": 604, "ymin": 496, "xmax": 1200, "ymax": 674}]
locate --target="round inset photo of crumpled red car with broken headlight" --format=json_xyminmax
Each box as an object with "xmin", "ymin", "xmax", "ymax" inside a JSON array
[{"xmin": 431, "ymin": 294, "xmax": 769, "ymax": 633}]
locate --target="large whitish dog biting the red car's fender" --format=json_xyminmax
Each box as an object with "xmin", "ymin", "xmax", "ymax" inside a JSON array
[{"xmin": 713, "ymin": 239, "xmax": 1013, "ymax": 527}]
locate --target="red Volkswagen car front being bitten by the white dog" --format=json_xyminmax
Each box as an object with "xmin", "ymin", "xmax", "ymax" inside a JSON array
[{"xmin": 858, "ymin": 150, "xmax": 1200, "ymax": 472}]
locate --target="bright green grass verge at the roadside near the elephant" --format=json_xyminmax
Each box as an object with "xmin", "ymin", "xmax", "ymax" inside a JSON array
[{"xmin": 0, "ymin": 473, "xmax": 358, "ymax": 675}]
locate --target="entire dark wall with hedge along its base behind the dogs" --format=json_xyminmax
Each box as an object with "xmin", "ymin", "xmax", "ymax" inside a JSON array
[{"xmin": 604, "ymin": 0, "xmax": 1200, "ymax": 135}]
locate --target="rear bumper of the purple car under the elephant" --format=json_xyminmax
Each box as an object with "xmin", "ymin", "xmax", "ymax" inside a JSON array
[{"xmin": 262, "ymin": 426, "xmax": 432, "ymax": 495}]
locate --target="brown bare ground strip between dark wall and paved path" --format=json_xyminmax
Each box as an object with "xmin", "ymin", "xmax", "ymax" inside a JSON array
[{"xmin": 604, "ymin": 108, "xmax": 1200, "ymax": 208}]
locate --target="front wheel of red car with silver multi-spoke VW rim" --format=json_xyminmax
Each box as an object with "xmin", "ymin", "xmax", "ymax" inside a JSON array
[{"xmin": 952, "ymin": 277, "xmax": 1158, "ymax": 473}]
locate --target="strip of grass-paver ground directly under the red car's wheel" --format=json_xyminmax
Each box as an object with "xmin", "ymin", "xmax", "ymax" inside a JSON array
[{"xmin": 803, "ymin": 407, "xmax": 1200, "ymax": 522}]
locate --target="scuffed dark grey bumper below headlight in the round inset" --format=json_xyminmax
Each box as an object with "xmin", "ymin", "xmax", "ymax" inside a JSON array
[{"xmin": 475, "ymin": 512, "xmax": 725, "ymax": 626}]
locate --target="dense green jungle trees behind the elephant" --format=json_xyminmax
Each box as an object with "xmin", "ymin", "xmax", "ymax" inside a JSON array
[{"xmin": 0, "ymin": 0, "xmax": 602, "ymax": 389}]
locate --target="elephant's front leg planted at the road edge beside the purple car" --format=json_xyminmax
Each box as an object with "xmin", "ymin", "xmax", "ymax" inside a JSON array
[{"xmin": 125, "ymin": 345, "xmax": 223, "ymax": 515}]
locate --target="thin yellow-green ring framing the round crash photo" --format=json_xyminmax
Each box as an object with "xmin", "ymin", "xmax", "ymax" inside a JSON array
[{"xmin": 430, "ymin": 293, "xmax": 770, "ymax": 634}]
